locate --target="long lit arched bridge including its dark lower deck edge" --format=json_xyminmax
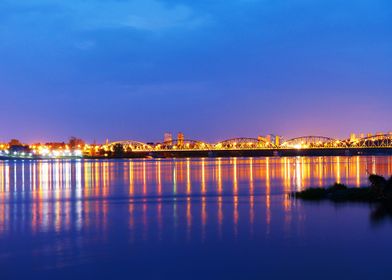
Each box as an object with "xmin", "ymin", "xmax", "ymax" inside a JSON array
[{"xmin": 103, "ymin": 134, "xmax": 392, "ymax": 157}]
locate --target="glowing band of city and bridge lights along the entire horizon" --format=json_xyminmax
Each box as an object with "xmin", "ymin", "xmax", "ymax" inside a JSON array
[{"xmin": 0, "ymin": 133, "xmax": 392, "ymax": 159}]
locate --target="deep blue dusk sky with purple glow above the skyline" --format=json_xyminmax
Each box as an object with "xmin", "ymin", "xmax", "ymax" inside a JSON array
[{"xmin": 0, "ymin": 0, "xmax": 392, "ymax": 142}]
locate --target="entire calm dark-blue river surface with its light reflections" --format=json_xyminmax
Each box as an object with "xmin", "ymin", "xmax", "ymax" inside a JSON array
[{"xmin": 0, "ymin": 157, "xmax": 392, "ymax": 279}]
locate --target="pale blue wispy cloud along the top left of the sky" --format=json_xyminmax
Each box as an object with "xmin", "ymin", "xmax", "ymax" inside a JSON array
[{"xmin": 2, "ymin": 0, "xmax": 205, "ymax": 31}]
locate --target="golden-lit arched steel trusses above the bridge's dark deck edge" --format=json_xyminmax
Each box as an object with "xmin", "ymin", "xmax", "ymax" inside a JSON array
[{"xmin": 103, "ymin": 134, "xmax": 392, "ymax": 152}]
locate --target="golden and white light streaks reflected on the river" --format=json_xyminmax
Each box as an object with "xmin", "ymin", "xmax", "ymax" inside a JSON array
[{"xmin": 0, "ymin": 157, "xmax": 392, "ymax": 239}]
